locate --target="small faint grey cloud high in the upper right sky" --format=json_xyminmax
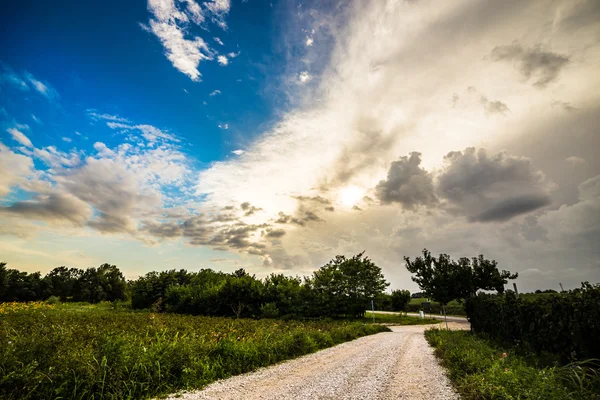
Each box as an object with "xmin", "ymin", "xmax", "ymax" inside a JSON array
[{"xmin": 492, "ymin": 43, "xmax": 569, "ymax": 88}]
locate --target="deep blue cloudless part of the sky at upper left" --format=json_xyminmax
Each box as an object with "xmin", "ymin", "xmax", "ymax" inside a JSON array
[{"xmin": 1, "ymin": 1, "xmax": 284, "ymax": 167}]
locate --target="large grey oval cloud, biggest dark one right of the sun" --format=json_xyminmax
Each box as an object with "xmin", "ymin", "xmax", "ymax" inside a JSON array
[{"xmin": 437, "ymin": 147, "xmax": 552, "ymax": 222}]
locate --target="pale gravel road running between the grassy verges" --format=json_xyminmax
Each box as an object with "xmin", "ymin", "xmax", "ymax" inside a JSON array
[{"xmin": 170, "ymin": 326, "xmax": 459, "ymax": 400}]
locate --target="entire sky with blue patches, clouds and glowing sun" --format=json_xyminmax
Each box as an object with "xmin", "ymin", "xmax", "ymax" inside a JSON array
[{"xmin": 0, "ymin": 0, "xmax": 600, "ymax": 291}]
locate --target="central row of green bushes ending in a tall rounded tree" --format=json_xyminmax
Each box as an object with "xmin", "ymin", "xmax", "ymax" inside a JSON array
[{"xmin": 130, "ymin": 253, "xmax": 390, "ymax": 318}]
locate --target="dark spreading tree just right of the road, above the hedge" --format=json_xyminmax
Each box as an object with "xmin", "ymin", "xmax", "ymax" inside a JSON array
[{"xmin": 404, "ymin": 249, "xmax": 518, "ymax": 305}]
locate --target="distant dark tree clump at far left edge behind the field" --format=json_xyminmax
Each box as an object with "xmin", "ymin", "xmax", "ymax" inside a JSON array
[{"xmin": 0, "ymin": 263, "xmax": 127, "ymax": 303}]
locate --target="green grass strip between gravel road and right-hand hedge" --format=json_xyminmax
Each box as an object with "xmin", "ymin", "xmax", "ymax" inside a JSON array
[{"xmin": 425, "ymin": 329, "xmax": 600, "ymax": 400}]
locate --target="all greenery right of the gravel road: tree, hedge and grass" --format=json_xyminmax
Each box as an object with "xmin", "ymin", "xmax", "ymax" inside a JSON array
[{"xmin": 405, "ymin": 249, "xmax": 600, "ymax": 399}]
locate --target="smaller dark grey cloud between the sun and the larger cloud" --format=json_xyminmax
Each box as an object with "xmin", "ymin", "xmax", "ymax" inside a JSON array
[{"xmin": 375, "ymin": 152, "xmax": 437, "ymax": 209}]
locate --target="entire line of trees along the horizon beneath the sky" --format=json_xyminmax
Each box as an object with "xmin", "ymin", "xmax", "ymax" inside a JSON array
[{"xmin": 0, "ymin": 249, "xmax": 517, "ymax": 318}]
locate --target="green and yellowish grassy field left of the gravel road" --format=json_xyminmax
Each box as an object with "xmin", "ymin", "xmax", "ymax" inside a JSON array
[{"xmin": 0, "ymin": 302, "xmax": 387, "ymax": 399}]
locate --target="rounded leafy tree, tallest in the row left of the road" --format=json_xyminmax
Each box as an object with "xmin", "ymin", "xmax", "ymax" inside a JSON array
[{"xmin": 311, "ymin": 252, "xmax": 389, "ymax": 317}]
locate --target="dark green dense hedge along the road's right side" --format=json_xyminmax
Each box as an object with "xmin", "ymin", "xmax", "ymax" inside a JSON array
[{"xmin": 466, "ymin": 283, "xmax": 600, "ymax": 362}]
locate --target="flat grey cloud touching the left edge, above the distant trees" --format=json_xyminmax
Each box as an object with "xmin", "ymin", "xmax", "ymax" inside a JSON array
[{"xmin": 0, "ymin": 193, "xmax": 92, "ymax": 226}]
